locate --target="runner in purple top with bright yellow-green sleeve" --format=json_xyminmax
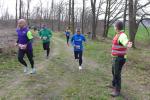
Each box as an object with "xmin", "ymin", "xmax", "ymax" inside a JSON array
[{"xmin": 16, "ymin": 19, "xmax": 35, "ymax": 74}]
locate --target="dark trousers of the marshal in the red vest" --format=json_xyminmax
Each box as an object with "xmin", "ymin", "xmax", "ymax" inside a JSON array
[{"xmin": 112, "ymin": 57, "xmax": 126, "ymax": 91}]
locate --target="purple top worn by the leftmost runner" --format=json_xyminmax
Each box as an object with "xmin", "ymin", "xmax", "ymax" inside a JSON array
[{"xmin": 16, "ymin": 27, "xmax": 32, "ymax": 50}]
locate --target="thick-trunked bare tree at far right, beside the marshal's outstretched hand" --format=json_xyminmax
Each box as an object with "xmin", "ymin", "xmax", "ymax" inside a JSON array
[{"xmin": 128, "ymin": 0, "xmax": 150, "ymax": 48}]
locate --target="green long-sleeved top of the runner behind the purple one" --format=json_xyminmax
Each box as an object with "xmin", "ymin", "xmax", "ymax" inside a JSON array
[{"xmin": 39, "ymin": 28, "xmax": 52, "ymax": 43}]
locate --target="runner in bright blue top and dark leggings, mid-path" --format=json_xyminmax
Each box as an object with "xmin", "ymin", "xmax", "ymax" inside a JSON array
[{"xmin": 71, "ymin": 28, "xmax": 86, "ymax": 70}]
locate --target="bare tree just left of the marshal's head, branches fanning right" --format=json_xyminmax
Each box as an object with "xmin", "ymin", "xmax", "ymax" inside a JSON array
[{"xmin": 103, "ymin": 0, "xmax": 124, "ymax": 37}]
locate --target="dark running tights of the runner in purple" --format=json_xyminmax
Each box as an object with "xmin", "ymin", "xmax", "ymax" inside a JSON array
[{"xmin": 18, "ymin": 49, "xmax": 34, "ymax": 68}]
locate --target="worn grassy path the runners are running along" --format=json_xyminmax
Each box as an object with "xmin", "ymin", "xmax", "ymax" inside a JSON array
[{"xmin": 0, "ymin": 33, "xmax": 149, "ymax": 100}]
